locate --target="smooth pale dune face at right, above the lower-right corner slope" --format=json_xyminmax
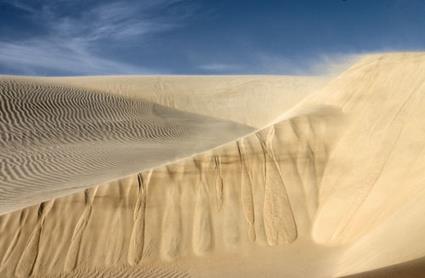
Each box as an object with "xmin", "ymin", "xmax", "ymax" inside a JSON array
[{"xmin": 313, "ymin": 54, "xmax": 425, "ymax": 244}]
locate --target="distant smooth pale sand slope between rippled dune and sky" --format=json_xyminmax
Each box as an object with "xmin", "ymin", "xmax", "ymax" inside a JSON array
[{"xmin": 47, "ymin": 75, "xmax": 330, "ymax": 128}]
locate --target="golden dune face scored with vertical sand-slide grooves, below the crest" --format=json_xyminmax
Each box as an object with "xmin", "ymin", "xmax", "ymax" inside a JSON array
[{"xmin": 0, "ymin": 102, "xmax": 340, "ymax": 277}]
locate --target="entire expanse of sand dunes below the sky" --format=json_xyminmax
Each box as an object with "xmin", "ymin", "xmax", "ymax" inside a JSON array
[{"xmin": 0, "ymin": 53, "xmax": 425, "ymax": 277}]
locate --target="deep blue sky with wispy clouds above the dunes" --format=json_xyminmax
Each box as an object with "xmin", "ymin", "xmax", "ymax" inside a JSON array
[{"xmin": 0, "ymin": 0, "xmax": 425, "ymax": 75}]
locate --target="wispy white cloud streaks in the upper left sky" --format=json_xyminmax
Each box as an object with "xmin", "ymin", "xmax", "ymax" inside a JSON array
[{"xmin": 0, "ymin": 0, "xmax": 192, "ymax": 74}]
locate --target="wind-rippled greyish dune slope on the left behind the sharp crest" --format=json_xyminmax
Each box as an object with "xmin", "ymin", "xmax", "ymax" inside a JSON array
[{"xmin": 0, "ymin": 78, "xmax": 251, "ymax": 213}]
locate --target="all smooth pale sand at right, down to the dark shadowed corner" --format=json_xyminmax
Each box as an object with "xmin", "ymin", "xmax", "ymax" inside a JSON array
[{"xmin": 304, "ymin": 53, "xmax": 425, "ymax": 275}]
